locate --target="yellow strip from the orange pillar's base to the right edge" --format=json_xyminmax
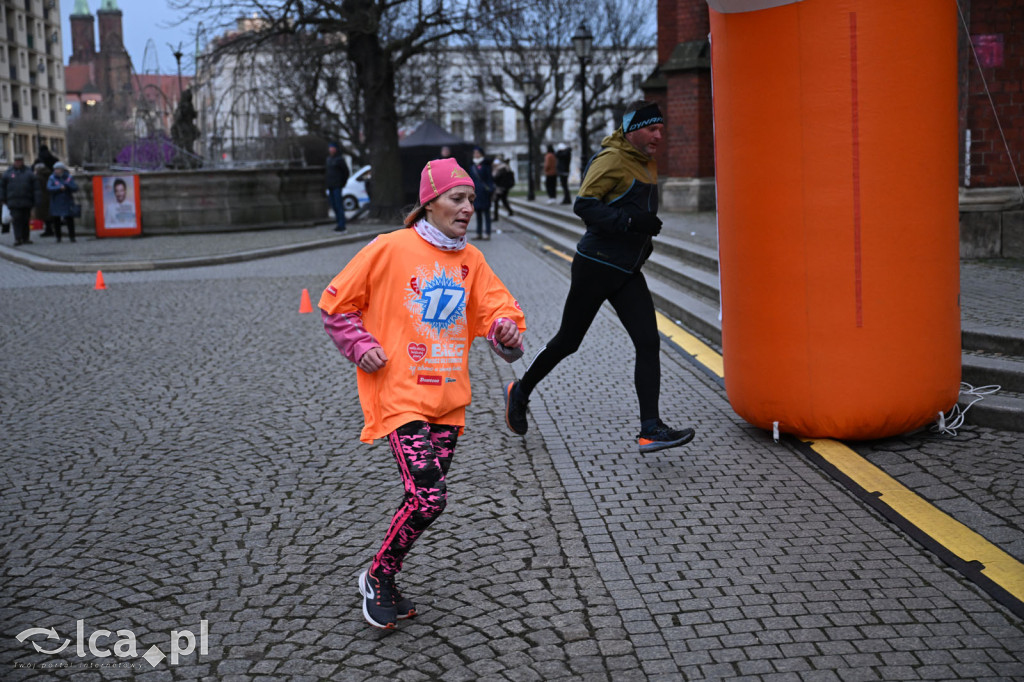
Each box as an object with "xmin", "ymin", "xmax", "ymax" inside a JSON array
[{"xmin": 805, "ymin": 439, "xmax": 1024, "ymax": 601}]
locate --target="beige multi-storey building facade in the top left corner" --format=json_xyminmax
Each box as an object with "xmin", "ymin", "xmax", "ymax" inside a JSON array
[{"xmin": 0, "ymin": 0, "xmax": 67, "ymax": 165}]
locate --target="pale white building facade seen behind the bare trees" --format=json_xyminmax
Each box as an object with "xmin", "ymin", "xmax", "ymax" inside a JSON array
[{"xmin": 194, "ymin": 18, "xmax": 656, "ymax": 182}]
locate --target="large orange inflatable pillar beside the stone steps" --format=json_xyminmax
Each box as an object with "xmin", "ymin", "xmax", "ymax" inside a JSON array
[{"xmin": 708, "ymin": 0, "xmax": 961, "ymax": 439}]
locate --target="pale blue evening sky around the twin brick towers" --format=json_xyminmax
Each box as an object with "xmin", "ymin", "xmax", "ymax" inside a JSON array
[{"xmin": 60, "ymin": 0, "xmax": 196, "ymax": 76}]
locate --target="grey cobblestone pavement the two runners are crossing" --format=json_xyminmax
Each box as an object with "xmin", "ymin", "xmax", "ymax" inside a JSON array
[{"xmin": 0, "ymin": 225, "xmax": 1024, "ymax": 682}]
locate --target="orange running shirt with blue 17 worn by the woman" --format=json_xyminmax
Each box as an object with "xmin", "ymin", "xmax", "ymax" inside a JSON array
[{"xmin": 319, "ymin": 227, "xmax": 526, "ymax": 442}]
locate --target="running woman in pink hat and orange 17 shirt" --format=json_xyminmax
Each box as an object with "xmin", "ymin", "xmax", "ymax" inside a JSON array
[{"xmin": 319, "ymin": 159, "xmax": 525, "ymax": 629}]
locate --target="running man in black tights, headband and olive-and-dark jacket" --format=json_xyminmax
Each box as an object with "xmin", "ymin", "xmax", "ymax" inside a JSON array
[{"xmin": 505, "ymin": 101, "xmax": 693, "ymax": 453}]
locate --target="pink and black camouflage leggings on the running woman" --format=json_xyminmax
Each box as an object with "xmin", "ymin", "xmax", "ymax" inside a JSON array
[{"xmin": 370, "ymin": 422, "xmax": 459, "ymax": 576}]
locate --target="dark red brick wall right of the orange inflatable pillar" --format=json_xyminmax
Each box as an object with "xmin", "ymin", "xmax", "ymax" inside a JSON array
[{"xmin": 959, "ymin": 0, "xmax": 1024, "ymax": 187}]
